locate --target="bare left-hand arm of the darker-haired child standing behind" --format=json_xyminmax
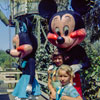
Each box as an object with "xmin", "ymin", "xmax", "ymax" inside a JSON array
[{"xmin": 48, "ymin": 71, "xmax": 56, "ymax": 99}]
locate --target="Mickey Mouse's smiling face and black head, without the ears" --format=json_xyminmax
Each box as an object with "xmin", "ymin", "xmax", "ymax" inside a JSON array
[{"xmin": 47, "ymin": 11, "xmax": 86, "ymax": 50}]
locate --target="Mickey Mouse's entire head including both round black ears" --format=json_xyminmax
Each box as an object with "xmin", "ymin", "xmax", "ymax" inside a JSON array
[{"xmin": 39, "ymin": 0, "xmax": 94, "ymax": 50}]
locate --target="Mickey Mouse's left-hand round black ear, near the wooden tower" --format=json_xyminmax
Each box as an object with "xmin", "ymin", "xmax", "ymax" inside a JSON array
[{"xmin": 38, "ymin": 0, "xmax": 57, "ymax": 19}]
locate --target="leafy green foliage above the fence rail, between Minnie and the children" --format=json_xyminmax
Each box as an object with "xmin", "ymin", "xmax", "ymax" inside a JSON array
[{"xmin": 36, "ymin": 44, "xmax": 53, "ymax": 71}]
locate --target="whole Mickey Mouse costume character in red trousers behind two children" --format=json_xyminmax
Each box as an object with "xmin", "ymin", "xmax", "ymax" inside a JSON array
[{"xmin": 39, "ymin": 0, "xmax": 91, "ymax": 96}]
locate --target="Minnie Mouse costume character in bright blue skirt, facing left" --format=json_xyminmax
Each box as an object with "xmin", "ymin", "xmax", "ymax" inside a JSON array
[{"xmin": 6, "ymin": 18, "xmax": 41, "ymax": 100}]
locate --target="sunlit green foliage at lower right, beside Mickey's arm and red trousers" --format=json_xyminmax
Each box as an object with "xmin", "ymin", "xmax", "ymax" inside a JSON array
[{"xmin": 81, "ymin": 39, "xmax": 100, "ymax": 100}]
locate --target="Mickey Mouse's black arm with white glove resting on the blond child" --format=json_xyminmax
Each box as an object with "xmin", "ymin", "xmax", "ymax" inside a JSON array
[{"xmin": 69, "ymin": 45, "xmax": 91, "ymax": 72}]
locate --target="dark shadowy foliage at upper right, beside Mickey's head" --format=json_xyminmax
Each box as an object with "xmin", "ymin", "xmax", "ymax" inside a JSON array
[{"xmin": 83, "ymin": 0, "xmax": 100, "ymax": 43}]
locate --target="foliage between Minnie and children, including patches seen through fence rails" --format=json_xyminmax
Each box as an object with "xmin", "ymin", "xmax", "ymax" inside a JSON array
[{"xmin": 36, "ymin": 43, "xmax": 53, "ymax": 94}]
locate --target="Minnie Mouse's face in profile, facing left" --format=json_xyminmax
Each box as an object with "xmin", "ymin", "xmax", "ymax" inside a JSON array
[{"xmin": 7, "ymin": 33, "xmax": 35, "ymax": 58}]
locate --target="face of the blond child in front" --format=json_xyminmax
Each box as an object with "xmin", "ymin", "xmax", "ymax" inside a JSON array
[{"xmin": 58, "ymin": 70, "xmax": 71, "ymax": 86}]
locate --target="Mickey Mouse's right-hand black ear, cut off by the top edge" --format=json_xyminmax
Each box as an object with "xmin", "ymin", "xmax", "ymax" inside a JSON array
[{"xmin": 71, "ymin": 0, "xmax": 91, "ymax": 15}]
